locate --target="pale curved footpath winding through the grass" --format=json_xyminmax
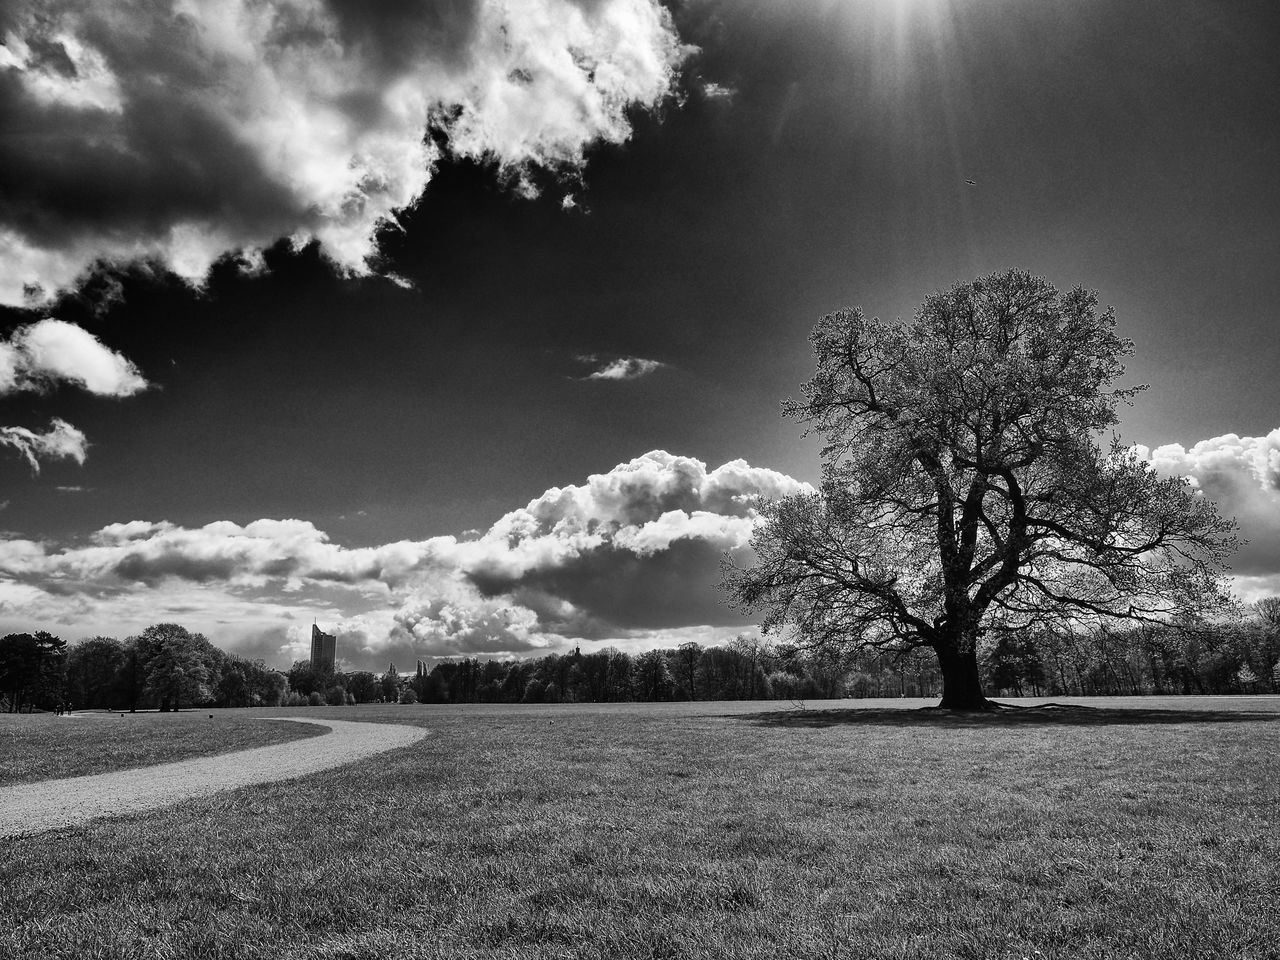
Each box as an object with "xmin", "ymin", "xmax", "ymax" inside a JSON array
[{"xmin": 0, "ymin": 717, "xmax": 426, "ymax": 837}]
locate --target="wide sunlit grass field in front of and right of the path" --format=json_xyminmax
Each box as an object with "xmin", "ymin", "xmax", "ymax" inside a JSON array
[{"xmin": 0, "ymin": 698, "xmax": 1280, "ymax": 960}]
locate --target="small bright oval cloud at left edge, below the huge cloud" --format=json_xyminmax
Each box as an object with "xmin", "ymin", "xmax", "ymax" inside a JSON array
[{"xmin": 0, "ymin": 319, "xmax": 147, "ymax": 397}]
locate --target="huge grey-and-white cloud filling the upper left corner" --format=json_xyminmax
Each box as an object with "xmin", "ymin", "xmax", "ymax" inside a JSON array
[{"xmin": 0, "ymin": 0, "xmax": 689, "ymax": 305}]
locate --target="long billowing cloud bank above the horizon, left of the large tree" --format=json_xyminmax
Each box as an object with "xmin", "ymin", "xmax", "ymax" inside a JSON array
[{"xmin": 0, "ymin": 451, "xmax": 808, "ymax": 662}]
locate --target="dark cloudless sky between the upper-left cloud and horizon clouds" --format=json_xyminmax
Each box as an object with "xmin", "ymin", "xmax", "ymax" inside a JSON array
[{"xmin": 0, "ymin": 0, "xmax": 1280, "ymax": 660}]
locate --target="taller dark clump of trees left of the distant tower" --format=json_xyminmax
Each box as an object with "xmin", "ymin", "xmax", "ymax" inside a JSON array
[{"xmin": 0, "ymin": 623, "xmax": 288, "ymax": 713}]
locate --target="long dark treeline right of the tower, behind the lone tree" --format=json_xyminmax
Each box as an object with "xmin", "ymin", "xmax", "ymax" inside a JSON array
[{"xmin": 380, "ymin": 609, "xmax": 1280, "ymax": 703}]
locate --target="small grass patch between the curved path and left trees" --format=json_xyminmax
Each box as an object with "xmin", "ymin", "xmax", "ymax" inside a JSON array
[{"xmin": 0, "ymin": 710, "xmax": 325, "ymax": 786}]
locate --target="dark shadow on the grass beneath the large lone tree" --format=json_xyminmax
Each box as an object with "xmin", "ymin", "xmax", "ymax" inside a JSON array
[{"xmin": 740, "ymin": 703, "xmax": 1280, "ymax": 728}]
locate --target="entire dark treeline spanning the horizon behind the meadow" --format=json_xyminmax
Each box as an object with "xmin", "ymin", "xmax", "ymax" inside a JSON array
[{"xmin": 0, "ymin": 598, "xmax": 1280, "ymax": 712}]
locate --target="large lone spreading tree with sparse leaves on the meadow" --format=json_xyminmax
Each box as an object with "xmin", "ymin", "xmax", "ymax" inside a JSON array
[{"xmin": 724, "ymin": 271, "xmax": 1235, "ymax": 709}]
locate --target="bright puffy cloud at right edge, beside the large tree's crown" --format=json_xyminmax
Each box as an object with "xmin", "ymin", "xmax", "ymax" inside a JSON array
[{"xmin": 1137, "ymin": 429, "xmax": 1280, "ymax": 585}]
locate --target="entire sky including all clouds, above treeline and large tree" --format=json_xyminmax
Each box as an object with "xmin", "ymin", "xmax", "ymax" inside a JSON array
[{"xmin": 0, "ymin": 0, "xmax": 1280, "ymax": 669}]
